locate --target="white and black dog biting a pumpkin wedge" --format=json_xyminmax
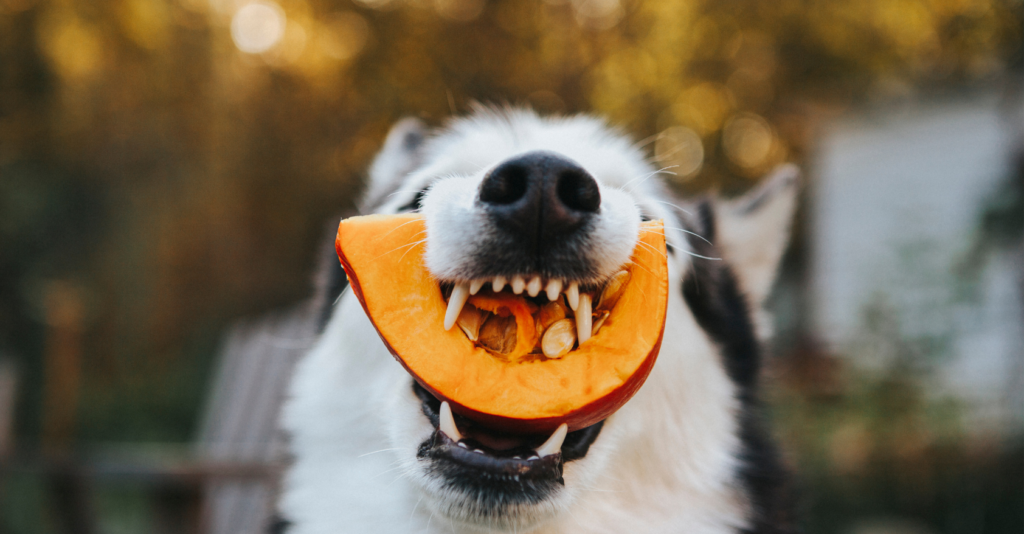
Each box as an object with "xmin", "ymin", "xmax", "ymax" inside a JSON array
[{"xmin": 279, "ymin": 108, "xmax": 798, "ymax": 534}]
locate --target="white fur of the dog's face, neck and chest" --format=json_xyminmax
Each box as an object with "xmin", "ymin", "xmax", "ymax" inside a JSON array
[{"xmin": 280, "ymin": 111, "xmax": 790, "ymax": 534}]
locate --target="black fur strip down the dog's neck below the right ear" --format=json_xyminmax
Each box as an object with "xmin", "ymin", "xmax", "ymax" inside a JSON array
[{"xmin": 683, "ymin": 202, "xmax": 797, "ymax": 534}]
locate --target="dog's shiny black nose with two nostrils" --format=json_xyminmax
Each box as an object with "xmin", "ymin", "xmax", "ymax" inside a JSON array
[{"xmin": 479, "ymin": 152, "xmax": 601, "ymax": 252}]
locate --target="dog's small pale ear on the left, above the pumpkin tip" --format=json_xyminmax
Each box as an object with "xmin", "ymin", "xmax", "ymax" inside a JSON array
[{"xmin": 359, "ymin": 117, "xmax": 427, "ymax": 213}]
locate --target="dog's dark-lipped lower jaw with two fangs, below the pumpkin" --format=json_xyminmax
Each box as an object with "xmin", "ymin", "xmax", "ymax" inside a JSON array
[{"xmin": 413, "ymin": 380, "xmax": 603, "ymax": 484}]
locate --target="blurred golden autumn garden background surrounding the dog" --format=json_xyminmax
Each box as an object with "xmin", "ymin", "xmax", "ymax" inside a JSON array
[{"xmin": 0, "ymin": 0, "xmax": 1024, "ymax": 534}]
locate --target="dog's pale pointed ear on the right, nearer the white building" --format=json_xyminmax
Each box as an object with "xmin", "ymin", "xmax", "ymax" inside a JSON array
[{"xmin": 714, "ymin": 164, "xmax": 800, "ymax": 310}]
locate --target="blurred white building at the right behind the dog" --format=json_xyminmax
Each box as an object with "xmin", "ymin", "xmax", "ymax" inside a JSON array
[{"xmin": 808, "ymin": 89, "xmax": 1024, "ymax": 436}]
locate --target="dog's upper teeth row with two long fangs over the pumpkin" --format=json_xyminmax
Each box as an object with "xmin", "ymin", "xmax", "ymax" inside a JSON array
[{"xmin": 444, "ymin": 275, "xmax": 591, "ymax": 343}]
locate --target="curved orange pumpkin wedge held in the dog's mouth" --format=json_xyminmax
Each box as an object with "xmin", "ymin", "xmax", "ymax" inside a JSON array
[{"xmin": 336, "ymin": 214, "xmax": 669, "ymax": 434}]
